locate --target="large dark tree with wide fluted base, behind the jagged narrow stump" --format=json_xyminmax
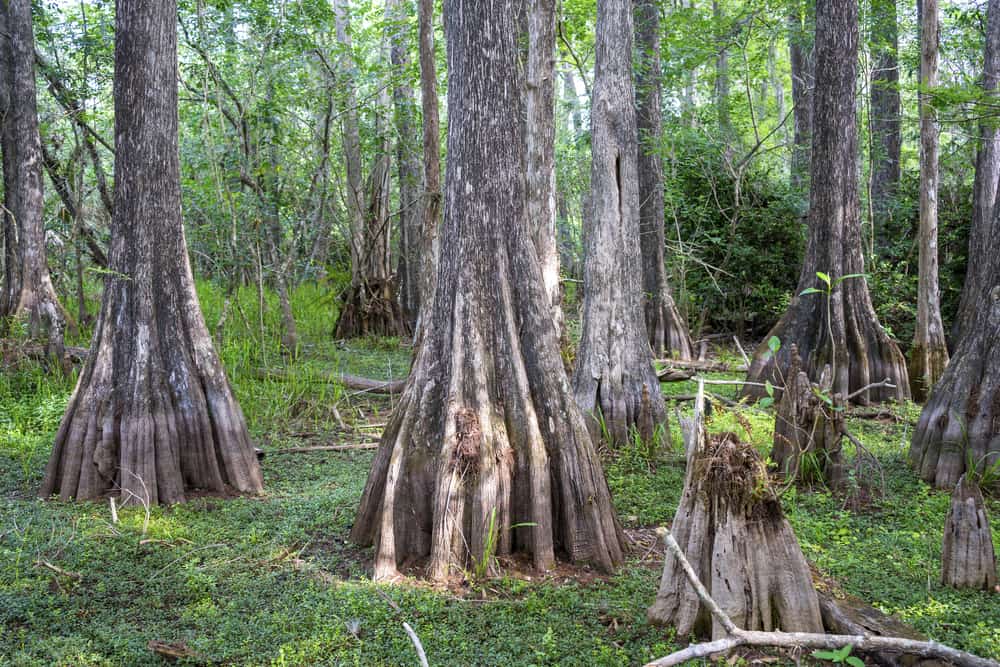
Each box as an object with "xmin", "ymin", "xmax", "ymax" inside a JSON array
[{"xmin": 743, "ymin": 0, "xmax": 909, "ymax": 404}]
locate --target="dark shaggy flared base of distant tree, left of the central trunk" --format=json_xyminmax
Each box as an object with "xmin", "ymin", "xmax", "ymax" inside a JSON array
[{"xmin": 333, "ymin": 280, "xmax": 411, "ymax": 339}]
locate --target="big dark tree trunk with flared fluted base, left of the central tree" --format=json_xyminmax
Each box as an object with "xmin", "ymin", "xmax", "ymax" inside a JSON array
[{"xmin": 40, "ymin": 0, "xmax": 263, "ymax": 504}]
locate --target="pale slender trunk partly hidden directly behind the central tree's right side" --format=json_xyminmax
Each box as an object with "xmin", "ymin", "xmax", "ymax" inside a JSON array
[{"xmin": 525, "ymin": 0, "xmax": 563, "ymax": 331}]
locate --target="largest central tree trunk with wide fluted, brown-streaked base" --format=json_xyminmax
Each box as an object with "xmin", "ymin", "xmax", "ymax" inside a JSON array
[{"xmin": 351, "ymin": 0, "xmax": 623, "ymax": 580}]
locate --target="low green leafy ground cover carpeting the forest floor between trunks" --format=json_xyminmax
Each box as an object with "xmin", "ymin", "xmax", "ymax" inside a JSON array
[{"xmin": 0, "ymin": 288, "xmax": 1000, "ymax": 666}]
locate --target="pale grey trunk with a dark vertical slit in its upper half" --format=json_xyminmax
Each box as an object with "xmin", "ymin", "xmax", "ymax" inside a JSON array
[{"xmin": 573, "ymin": 0, "xmax": 666, "ymax": 442}]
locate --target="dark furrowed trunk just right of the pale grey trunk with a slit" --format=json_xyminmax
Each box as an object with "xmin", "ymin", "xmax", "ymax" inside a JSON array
[{"xmin": 635, "ymin": 0, "xmax": 693, "ymax": 359}]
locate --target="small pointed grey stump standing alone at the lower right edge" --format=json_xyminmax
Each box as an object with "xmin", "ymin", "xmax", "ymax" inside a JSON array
[{"xmin": 941, "ymin": 475, "xmax": 997, "ymax": 590}]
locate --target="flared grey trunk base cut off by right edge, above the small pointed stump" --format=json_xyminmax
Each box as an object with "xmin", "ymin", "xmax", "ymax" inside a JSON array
[{"xmin": 910, "ymin": 284, "xmax": 1000, "ymax": 489}]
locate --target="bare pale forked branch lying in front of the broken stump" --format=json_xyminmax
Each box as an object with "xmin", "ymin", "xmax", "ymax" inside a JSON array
[{"xmin": 646, "ymin": 528, "xmax": 1000, "ymax": 667}]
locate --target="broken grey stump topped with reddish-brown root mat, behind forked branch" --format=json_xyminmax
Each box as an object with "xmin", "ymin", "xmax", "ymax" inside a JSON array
[{"xmin": 647, "ymin": 425, "xmax": 823, "ymax": 639}]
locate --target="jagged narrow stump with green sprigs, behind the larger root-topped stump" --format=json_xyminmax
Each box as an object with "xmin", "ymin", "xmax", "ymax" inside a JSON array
[{"xmin": 771, "ymin": 345, "xmax": 845, "ymax": 486}]
